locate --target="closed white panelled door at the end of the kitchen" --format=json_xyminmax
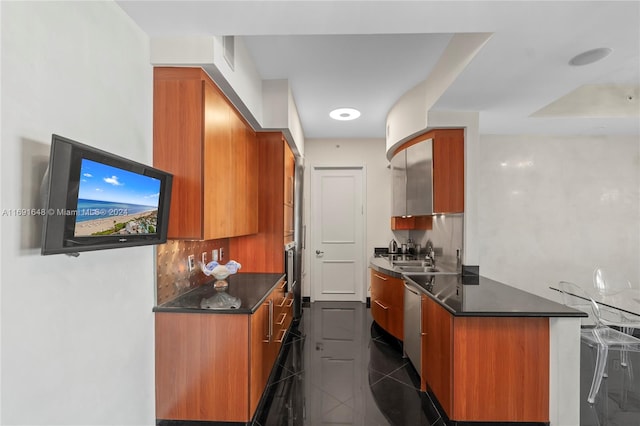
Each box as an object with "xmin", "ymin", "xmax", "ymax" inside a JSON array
[{"xmin": 309, "ymin": 167, "xmax": 366, "ymax": 302}]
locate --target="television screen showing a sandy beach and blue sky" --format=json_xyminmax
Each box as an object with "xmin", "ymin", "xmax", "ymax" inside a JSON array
[{"xmin": 74, "ymin": 158, "xmax": 160, "ymax": 237}]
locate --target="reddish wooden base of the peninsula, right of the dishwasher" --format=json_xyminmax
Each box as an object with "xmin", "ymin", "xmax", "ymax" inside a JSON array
[{"xmin": 421, "ymin": 295, "xmax": 549, "ymax": 422}]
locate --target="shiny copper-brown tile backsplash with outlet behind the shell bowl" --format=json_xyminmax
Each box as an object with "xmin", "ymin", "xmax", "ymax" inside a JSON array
[{"xmin": 156, "ymin": 238, "xmax": 231, "ymax": 305}]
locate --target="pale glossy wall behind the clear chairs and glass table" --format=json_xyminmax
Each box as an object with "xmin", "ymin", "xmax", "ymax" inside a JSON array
[{"xmin": 477, "ymin": 135, "xmax": 640, "ymax": 301}]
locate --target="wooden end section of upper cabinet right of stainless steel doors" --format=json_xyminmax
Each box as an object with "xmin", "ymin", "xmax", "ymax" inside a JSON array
[{"xmin": 433, "ymin": 129, "xmax": 464, "ymax": 213}]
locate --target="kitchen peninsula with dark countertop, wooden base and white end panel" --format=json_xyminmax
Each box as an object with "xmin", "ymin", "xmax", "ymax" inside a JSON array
[{"xmin": 369, "ymin": 257, "xmax": 586, "ymax": 426}]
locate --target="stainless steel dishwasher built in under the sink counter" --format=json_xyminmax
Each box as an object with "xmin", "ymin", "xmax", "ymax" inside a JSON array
[{"xmin": 404, "ymin": 280, "xmax": 422, "ymax": 376}]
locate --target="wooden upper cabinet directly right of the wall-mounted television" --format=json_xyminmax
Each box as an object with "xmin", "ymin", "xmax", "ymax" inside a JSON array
[{"xmin": 153, "ymin": 68, "xmax": 258, "ymax": 240}]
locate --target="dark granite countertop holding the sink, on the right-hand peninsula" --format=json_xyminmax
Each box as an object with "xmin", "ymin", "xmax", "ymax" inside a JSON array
[{"xmin": 369, "ymin": 258, "xmax": 586, "ymax": 317}]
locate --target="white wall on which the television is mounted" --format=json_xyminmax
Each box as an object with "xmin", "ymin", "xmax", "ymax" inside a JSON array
[{"xmin": 0, "ymin": 2, "xmax": 155, "ymax": 425}]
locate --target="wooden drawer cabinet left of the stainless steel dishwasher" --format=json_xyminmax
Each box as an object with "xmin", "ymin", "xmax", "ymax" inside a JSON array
[{"xmin": 371, "ymin": 269, "xmax": 404, "ymax": 340}]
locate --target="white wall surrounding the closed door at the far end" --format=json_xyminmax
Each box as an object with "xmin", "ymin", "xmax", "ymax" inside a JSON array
[{"xmin": 302, "ymin": 139, "xmax": 393, "ymax": 296}]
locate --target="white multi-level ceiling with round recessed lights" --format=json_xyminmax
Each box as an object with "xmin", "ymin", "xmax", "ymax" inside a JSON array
[{"xmin": 117, "ymin": 1, "xmax": 640, "ymax": 138}]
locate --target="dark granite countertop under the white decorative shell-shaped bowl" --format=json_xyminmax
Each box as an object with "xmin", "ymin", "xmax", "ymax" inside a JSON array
[{"xmin": 153, "ymin": 273, "xmax": 284, "ymax": 314}]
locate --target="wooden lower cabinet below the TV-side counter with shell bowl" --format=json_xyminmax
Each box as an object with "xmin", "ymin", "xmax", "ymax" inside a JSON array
[{"xmin": 155, "ymin": 282, "xmax": 293, "ymax": 422}]
